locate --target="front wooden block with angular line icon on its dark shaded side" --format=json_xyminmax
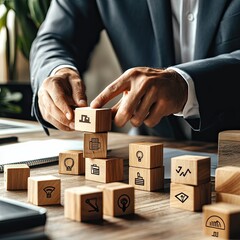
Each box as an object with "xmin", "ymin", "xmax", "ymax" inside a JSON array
[{"xmin": 64, "ymin": 186, "xmax": 103, "ymax": 222}]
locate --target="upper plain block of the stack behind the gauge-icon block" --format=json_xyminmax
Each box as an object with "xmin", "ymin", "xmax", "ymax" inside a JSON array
[{"xmin": 215, "ymin": 166, "xmax": 240, "ymax": 195}]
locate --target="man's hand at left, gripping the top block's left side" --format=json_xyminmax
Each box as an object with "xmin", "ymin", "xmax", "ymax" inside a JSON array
[{"xmin": 38, "ymin": 68, "xmax": 87, "ymax": 131}]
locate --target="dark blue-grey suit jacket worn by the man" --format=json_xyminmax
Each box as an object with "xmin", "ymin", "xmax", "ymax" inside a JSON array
[{"xmin": 30, "ymin": 0, "xmax": 240, "ymax": 141}]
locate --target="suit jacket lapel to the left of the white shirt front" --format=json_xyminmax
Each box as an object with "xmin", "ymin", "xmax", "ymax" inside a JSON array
[{"xmin": 147, "ymin": 0, "xmax": 175, "ymax": 67}]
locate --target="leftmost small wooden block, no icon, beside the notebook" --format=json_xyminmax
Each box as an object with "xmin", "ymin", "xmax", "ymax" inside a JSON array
[{"xmin": 4, "ymin": 164, "xmax": 30, "ymax": 190}]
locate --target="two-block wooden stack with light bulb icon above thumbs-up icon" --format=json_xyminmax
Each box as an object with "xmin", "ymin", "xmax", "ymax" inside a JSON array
[{"xmin": 129, "ymin": 142, "xmax": 164, "ymax": 191}]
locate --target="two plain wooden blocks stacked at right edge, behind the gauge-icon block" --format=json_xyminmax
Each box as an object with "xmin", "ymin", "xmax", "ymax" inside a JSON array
[{"xmin": 215, "ymin": 166, "xmax": 240, "ymax": 205}]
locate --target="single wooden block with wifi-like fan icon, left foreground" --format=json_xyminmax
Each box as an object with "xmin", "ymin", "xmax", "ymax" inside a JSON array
[{"xmin": 28, "ymin": 175, "xmax": 61, "ymax": 205}]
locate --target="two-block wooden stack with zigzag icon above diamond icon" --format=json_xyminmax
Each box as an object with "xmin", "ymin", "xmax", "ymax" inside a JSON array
[{"xmin": 170, "ymin": 155, "xmax": 211, "ymax": 211}]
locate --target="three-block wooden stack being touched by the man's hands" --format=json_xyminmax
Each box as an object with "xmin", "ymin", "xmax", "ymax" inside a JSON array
[{"xmin": 75, "ymin": 107, "xmax": 123, "ymax": 183}]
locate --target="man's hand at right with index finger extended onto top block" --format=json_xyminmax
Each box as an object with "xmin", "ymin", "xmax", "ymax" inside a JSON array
[{"xmin": 90, "ymin": 67, "xmax": 188, "ymax": 127}]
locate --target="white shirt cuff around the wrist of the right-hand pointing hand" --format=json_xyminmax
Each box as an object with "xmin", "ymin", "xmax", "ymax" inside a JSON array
[{"xmin": 168, "ymin": 67, "xmax": 200, "ymax": 118}]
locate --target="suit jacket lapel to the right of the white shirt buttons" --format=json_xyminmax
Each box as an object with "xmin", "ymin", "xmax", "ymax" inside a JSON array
[{"xmin": 195, "ymin": 0, "xmax": 228, "ymax": 59}]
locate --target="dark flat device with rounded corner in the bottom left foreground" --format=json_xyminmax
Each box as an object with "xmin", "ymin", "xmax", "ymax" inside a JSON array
[{"xmin": 0, "ymin": 197, "xmax": 47, "ymax": 236}]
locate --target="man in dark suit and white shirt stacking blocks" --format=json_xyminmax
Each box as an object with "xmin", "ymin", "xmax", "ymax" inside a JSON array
[{"xmin": 30, "ymin": 0, "xmax": 240, "ymax": 141}]
